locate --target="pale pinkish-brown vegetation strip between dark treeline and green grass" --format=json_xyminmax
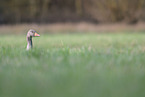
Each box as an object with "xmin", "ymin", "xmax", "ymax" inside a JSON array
[{"xmin": 0, "ymin": 22, "xmax": 145, "ymax": 34}]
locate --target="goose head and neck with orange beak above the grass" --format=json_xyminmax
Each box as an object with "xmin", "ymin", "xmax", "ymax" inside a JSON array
[{"xmin": 26, "ymin": 29, "xmax": 40, "ymax": 50}]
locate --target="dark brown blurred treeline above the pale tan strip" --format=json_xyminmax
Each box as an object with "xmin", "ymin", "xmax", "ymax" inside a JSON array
[{"xmin": 0, "ymin": 0, "xmax": 145, "ymax": 24}]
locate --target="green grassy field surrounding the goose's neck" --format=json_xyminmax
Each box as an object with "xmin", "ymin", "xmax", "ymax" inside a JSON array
[{"xmin": 0, "ymin": 33, "xmax": 145, "ymax": 97}]
